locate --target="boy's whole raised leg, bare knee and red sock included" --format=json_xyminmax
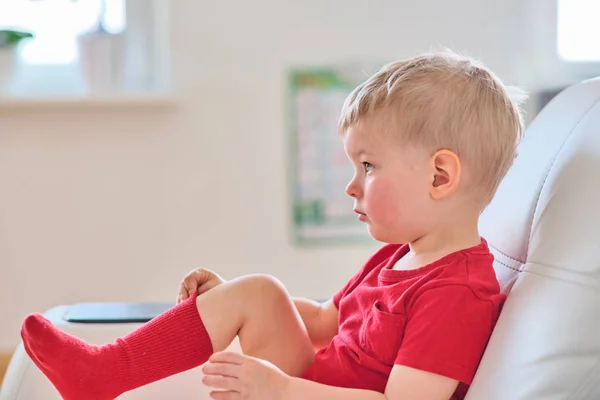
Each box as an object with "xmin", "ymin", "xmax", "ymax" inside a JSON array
[{"xmin": 22, "ymin": 276, "xmax": 313, "ymax": 400}]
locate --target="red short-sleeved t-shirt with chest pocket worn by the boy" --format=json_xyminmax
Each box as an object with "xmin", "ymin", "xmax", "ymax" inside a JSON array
[{"xmin": 303, "ymin": 239, "xmax": 505, "ymax": 400}]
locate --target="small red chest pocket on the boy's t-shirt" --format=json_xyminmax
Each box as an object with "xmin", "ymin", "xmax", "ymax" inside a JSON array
[{"xmin": 359, "ymin": 300, "xmax": 406, "ymax": 365}]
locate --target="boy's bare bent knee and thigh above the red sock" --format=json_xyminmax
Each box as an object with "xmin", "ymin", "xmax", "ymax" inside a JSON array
[{"xmin": 196, "ymin": 275, "xmax": 314, "ymax": 376}]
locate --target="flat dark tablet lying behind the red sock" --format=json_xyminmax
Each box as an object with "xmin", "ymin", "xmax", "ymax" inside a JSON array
[{"xmin": 63, "ymin": 303, "xmax": 175, "ymax": 324}]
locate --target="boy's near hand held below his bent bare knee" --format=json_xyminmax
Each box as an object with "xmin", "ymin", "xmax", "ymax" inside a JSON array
[{"xmin": 202, "ymin": 352, "xmax": 290, "ymax": 400}]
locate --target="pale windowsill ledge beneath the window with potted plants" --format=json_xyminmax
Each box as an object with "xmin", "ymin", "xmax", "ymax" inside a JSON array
[{"xmin": 0, "ymin": 93, "xmax": 177, "ymax": 111}]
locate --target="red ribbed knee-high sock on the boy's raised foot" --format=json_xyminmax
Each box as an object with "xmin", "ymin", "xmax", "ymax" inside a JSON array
[{"xmin": 21, "ymin": 296, "xmax": 213, "ymax": 400}]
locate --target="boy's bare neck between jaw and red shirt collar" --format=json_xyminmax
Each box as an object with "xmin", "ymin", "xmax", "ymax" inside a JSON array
[{"xmin": 394, "ymin": 211, "xmax": 481, "ymax": 270}]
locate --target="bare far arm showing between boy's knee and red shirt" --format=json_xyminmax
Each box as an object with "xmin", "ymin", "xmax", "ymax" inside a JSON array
[{"xmin": 293, "ymin": 298, "xmax": 338, "ymax": 349}]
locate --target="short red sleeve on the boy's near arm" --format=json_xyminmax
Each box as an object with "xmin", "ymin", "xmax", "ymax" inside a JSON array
[{"xmin": 395, "ymin": 285, "xmax": 498, "ymax": 385}]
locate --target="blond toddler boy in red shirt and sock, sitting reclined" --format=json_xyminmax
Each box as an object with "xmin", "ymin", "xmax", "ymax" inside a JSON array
[{"xmin": 22, "ymin": 53, "xmax": 523, "ymax": 400}]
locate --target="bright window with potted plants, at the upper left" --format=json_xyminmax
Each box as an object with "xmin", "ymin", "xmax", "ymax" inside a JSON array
[{"xmin": 0, "ymin": 0, "xmax": 170, "ymax": 101}]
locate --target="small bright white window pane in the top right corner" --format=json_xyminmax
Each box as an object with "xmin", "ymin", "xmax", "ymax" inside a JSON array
[{"xmin": 557, "ymin": 0, "xmax": 600, "ymax": 62}]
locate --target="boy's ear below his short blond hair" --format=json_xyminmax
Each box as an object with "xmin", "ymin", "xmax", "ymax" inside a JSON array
[{"xmin": 430, "ymin": 150, "xmax": 461, "ymax": 200}]
